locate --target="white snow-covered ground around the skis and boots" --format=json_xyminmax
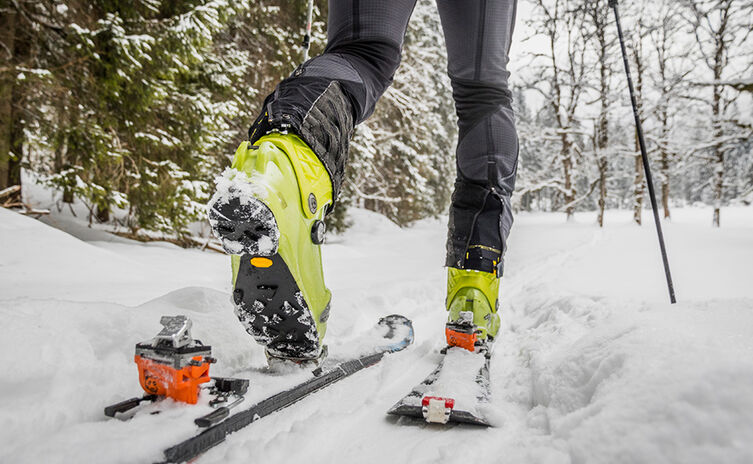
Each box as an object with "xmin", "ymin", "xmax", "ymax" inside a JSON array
[{"xmin": 0, "ymin": 207, "xmax": 753, "ymax": 463}]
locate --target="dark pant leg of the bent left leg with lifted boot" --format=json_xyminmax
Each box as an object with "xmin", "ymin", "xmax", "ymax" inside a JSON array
[{"xmin": 249, "ymin": 0, "xmax": 416, "ymax": 203}]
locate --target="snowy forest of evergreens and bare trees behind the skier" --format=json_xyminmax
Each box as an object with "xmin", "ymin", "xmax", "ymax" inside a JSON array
[{"xmin": 0, "ymin": 0, "xmax": 753, "ymax": 239}]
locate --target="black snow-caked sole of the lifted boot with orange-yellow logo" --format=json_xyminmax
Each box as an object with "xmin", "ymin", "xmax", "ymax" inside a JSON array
[{"xmin": 209, "ymin": 194, "xmax": 329, "ymax": 358}]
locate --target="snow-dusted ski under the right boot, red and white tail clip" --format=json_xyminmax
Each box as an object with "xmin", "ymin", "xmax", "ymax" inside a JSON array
[{"xmin": 387, "ymin": 347, "xmax": 491, "ymax": 426}]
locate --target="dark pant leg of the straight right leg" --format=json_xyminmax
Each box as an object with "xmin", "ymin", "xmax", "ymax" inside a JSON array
[{"xmin": 437, "ymin": 0, "xmax": 518, "ymax": 275}]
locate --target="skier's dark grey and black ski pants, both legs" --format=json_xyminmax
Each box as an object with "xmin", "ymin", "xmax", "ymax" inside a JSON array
[{"xmin": 249, "ymin": 0, "xmax": 518, "ymax": 274}]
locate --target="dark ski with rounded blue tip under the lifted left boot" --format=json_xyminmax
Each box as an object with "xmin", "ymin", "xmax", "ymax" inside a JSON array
[{"xmin": 158, "ymin": 314, "xmax": 413, "ymax": 463}]
